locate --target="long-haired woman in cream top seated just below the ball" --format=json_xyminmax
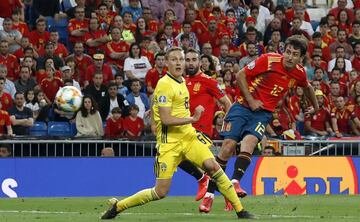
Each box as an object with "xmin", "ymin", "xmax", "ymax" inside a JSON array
[{"xmin": 75, "ymin": 95, "xmax": 104, "ymax": 137}]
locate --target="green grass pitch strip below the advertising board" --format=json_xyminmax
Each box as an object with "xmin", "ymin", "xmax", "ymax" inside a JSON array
[{"xmin": 0, "ymin": 195, "xmax": 360, "ymax": 222}]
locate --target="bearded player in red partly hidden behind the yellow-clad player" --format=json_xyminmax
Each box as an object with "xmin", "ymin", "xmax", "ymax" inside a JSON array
[{"xmin": 183, "ymin": 49, "xmax": 231, "ymax": 203}]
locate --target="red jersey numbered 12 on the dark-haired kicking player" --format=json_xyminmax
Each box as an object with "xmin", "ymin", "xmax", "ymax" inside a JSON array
[{"xmin": 238, "ymin": 53, "xmax": 309, "ymax": 112}]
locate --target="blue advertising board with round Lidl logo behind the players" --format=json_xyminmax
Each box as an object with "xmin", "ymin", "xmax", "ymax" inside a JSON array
[{"xmin": 0, "ymin": 157, "xmax": 360, "ymax": 198}]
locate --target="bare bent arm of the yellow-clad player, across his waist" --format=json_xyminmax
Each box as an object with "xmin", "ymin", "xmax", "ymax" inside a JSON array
[{"xmin": 159, "ymin": 107, "xmax": 202, "ymax": 126}]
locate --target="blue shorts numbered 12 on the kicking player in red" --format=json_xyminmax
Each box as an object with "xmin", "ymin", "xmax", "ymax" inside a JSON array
[{"xmin": 220, "ymin": 103, "xmax": 272, "ymax": 142}]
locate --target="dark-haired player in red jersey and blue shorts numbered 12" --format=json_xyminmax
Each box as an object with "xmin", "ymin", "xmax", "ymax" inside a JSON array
[{"xmin": 200, "ymin": 35, "xmax": 319, "ymax": 212}]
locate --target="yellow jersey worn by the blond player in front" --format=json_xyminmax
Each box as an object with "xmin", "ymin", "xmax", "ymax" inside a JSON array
[{"xmin": 153, "ymin": 73, "xmax": 196, "ymax": 144}]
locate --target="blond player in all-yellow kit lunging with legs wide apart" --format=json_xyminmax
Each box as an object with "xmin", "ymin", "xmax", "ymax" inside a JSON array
[{"xmin": 101, "ymin": 48, "xmax": 254, "ymax": 219}]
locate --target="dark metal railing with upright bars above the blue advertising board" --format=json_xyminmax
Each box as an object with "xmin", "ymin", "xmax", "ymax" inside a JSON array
[{"xmin": 0, "ymin": 138, "xmax": 360, "ymax": 157}]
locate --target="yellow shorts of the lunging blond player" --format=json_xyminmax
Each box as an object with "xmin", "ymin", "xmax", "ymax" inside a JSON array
[{"xmin": 154, "ymin": 132, "xmax": 214, "ymax": 179}]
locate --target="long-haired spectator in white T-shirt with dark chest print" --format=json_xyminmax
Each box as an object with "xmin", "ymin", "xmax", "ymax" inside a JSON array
[{"xmin": 124, "ymin": 43, "xmax": 152, "ymax": 83}]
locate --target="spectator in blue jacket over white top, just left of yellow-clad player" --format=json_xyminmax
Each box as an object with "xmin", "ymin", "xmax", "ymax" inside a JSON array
[{"xmin": 126, "ymin": 79, "xmax": 150, "ymax": 119}]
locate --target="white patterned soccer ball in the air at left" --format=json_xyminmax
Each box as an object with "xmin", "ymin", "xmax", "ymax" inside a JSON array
[{"xmin": 55, "ymin": 86, "xmax": 83, "ymax": 112}]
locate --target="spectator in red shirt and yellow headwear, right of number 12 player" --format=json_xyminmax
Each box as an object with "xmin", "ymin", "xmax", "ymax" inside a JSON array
[{"xmin": 305, "ymin": 90, "xmax": 334, "ymax": 136}]
